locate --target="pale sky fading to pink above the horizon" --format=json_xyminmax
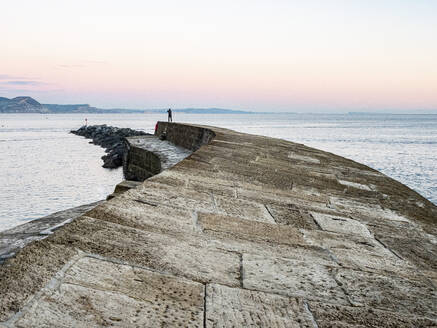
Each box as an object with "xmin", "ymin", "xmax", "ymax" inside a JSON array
[{"xmin": 0, "ymin": 0, "xmax": 437, "ymax": 113}]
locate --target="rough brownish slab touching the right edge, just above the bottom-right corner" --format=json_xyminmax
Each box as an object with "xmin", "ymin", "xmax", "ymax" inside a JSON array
[{"xmin": 336, "ymin": 269, "xmax": 437, "ymax": 319}]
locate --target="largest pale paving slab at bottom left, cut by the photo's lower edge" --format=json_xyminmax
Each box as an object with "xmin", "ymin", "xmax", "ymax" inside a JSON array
[{"xmin": 16, "ymin": 257, "xmax": 204, "ymax": 327}]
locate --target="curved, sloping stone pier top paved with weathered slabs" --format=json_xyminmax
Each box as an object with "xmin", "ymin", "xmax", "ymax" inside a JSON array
[{"xmin": 0, "ymin": 123, "xmax": 437, "ymax": 328}]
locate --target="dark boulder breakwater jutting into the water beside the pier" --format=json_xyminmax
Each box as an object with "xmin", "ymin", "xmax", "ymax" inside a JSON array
[{"xmin": 70, "ymin": 124, "xmax": 150, "ymax": 169}]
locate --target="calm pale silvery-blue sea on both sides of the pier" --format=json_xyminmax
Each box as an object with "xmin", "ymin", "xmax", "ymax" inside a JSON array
[{"xmin": 0, "ymin": 113, "xmax": 437, "ymax": 231}]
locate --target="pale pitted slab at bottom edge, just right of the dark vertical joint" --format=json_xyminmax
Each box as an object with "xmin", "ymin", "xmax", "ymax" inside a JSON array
[{"xmin": 206, "ymin": 284, "xmax": 315, "ymax": 328}]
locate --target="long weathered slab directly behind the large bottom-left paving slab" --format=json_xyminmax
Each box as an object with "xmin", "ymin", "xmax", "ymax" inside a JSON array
[{"xmin": 53, "ymin": 217, "xmax": 240, "ymax": 286}]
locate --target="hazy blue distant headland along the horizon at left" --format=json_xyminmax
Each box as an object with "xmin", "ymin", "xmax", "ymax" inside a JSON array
[{"xmin": 0, "ymin": 96, "xmax": 254, "ymax": 114}]
